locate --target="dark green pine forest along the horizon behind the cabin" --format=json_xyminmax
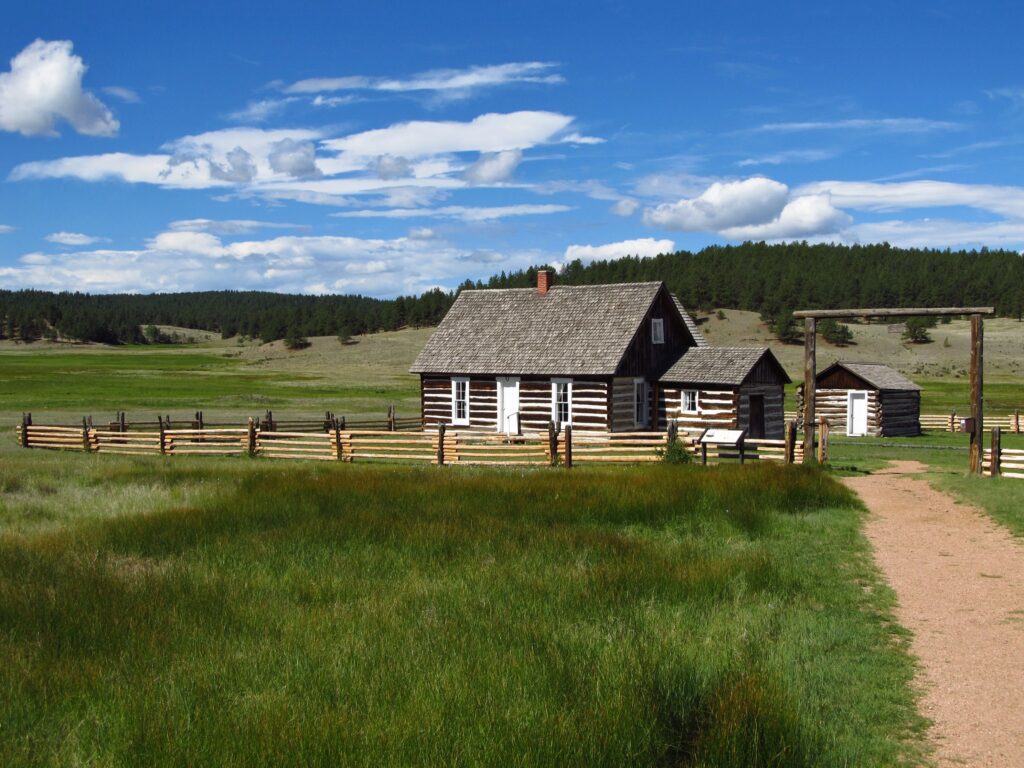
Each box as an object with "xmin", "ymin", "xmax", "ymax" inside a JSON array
[{"xmin": 0, "ymin": 243, "xmax": 1024, "ymax": 343}]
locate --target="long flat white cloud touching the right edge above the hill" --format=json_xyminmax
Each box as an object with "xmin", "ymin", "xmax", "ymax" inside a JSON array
[{"xmin": 797, "ymin": 180, "xmax": 1024, "ymax": 218}]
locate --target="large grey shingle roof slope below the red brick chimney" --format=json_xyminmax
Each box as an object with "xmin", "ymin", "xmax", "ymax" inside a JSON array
[{"xmin": 410, "ymin": 283, "xmax": 671, "ymax": 376}]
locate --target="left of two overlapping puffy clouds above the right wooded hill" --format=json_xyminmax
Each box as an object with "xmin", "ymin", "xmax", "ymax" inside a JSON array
[{"xmin": 643, "ymin": 176, "xmax": 790, "ymax": 231}]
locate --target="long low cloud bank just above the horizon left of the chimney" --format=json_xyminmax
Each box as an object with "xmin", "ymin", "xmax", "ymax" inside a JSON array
[{"xmin": 0, "ymin": 230, "xmax": 550, "ymax": 296}]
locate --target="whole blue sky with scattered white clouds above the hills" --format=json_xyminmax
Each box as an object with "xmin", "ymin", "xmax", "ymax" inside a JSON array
[{"xmin": 0, "ymin": 1, "xmax": 1024, "ymax": 296}]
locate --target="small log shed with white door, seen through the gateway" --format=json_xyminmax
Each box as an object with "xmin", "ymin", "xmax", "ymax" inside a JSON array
[{"xmin": 797, "ymin": 360, "xmax": 921, "ymax": 437}]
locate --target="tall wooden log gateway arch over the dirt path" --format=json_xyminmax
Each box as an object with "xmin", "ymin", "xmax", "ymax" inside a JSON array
[{"xmin": 793, "ymin": 306, "xmax": 995, "ymax": 474}]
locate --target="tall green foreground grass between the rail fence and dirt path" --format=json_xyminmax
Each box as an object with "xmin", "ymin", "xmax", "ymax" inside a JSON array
[{"xmin": 0, "ymin": 452, "xmax": 923, "ymax": 766}]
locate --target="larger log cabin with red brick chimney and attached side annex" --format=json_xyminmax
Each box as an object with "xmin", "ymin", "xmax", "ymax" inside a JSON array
[{"xmin": 410, "ymin": 270, "xmax": 788, "ymax": 436}]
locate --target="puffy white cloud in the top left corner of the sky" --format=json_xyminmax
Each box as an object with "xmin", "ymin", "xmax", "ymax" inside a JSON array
[{"xmin": 0, "ymin": 40, "xmax": 120, "ymax": 136}]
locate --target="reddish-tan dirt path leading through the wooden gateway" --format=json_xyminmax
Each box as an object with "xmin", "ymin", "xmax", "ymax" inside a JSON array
[{"xmin": 844, "ymin": 462, "xmax": 1024, "ymax": 766}]
